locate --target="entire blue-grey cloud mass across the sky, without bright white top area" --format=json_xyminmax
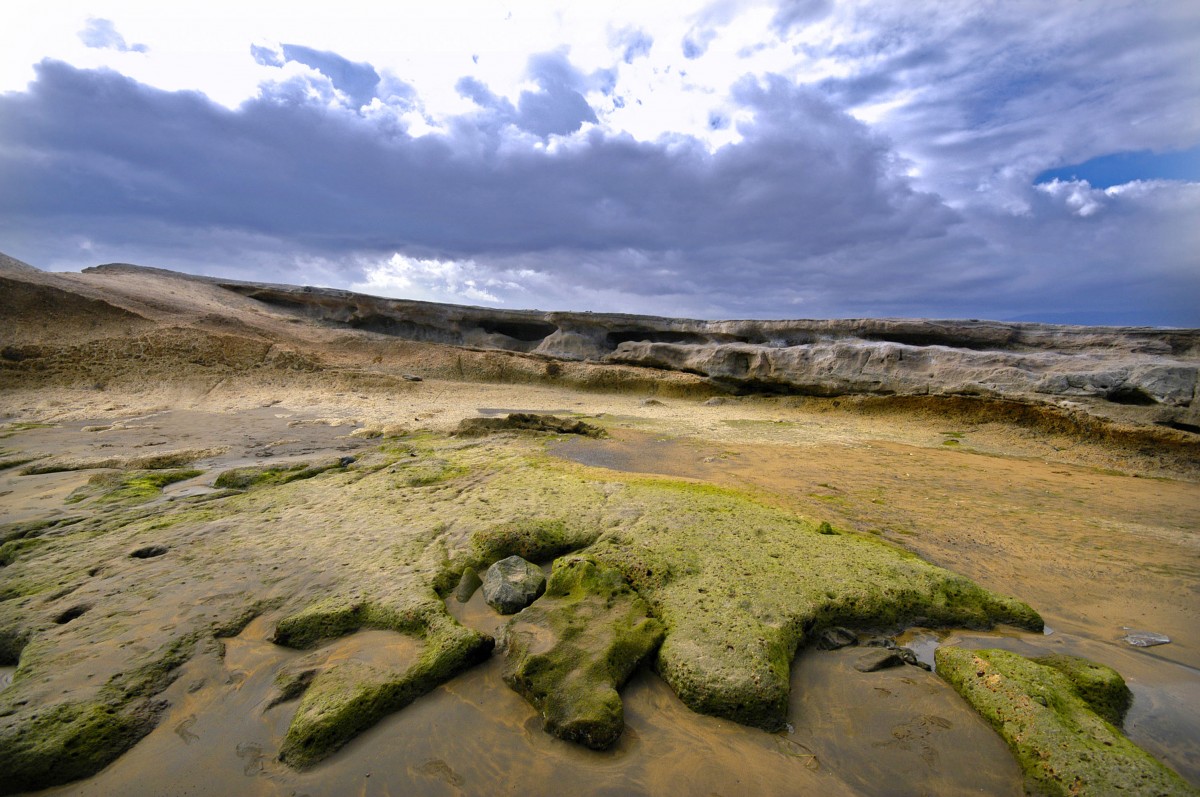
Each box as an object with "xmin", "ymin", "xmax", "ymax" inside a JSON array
[{"xmin": 0, "ymin": 14, "xmax": 1200, "ymax": 324}]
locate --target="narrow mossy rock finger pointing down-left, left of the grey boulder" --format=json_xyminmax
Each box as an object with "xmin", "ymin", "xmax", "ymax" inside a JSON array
[{"xmin": 280, "ymin": 616, "xmax": 493, "ymax": 768}]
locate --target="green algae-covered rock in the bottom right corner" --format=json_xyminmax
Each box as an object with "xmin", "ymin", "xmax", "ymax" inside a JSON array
[{"xmin": 935, "ymin": 647, "xmax": 1198, "ymax": 795}]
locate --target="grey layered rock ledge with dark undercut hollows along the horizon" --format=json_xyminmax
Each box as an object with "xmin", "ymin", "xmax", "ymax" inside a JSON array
[{"xmin": 204, "ymin": 266, "xmax": 1200, "ymax": 432}]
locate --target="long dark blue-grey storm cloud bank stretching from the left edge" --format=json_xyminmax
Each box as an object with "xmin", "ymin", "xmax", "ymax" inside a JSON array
[{"xmin": 0, "ymin": 61, "xmax": 954, "ymax": 264}]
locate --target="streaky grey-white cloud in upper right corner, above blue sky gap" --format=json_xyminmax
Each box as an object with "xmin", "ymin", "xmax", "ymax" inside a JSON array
[{"xmin": 806, "ymin": 0, "xmax": 1200, "ymax": 214}]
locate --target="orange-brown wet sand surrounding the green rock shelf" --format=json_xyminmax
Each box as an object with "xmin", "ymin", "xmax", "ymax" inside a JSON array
[{"xmin": 0, "ymin": 385, "xmax": 1200, "ymax": 795}]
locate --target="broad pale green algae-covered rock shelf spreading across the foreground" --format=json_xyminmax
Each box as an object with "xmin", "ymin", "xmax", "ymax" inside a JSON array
[{"xmin": 0, "ymin": 435, "xmax": 1040, "ymax": 782}]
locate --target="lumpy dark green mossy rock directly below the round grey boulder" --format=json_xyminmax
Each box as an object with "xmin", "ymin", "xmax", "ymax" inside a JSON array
[{"xmin": 504, "ymin": 556, "xmax": 664, "ymax": 749}]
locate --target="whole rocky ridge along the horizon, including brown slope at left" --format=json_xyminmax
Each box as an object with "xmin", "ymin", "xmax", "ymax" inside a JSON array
[{"xmin": 0, "ymin": 259, "xmax": 1200, "ymax": 436}]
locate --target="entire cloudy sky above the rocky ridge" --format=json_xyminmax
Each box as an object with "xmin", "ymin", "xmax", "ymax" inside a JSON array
[{"xmin": 0, "ymin": 0, "xmax": 1200, "ymax": 326}]
